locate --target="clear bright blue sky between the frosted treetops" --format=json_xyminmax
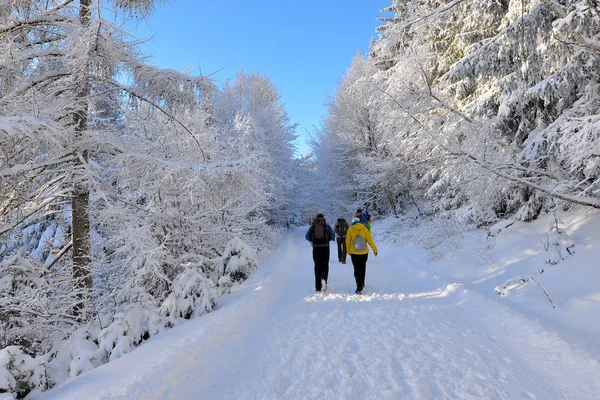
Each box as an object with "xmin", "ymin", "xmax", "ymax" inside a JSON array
[{"xmin": 129, "ymin": 0, "xmax": 390, "ymax": 153}]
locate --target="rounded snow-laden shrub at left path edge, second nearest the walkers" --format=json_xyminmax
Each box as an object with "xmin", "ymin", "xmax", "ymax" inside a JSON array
[{"xmin": 160, "ymin": 264, "xmax": 219, "ymax": 319}]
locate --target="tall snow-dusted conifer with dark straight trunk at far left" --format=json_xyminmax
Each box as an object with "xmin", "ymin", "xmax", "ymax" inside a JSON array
[{"xmin": 0, "ymin": 0, "xmax": 224, "ymax": 351}]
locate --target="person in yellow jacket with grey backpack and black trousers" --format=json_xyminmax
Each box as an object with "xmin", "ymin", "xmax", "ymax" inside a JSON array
[{"xmin": 346, "ymin": 217, "xmax": 378, "ymax": 294}]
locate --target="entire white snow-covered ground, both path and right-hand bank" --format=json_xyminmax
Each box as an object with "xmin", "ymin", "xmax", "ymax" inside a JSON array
[{"xmin": 29, "ymin": 211, "xmax": 600, "ymax": 400}]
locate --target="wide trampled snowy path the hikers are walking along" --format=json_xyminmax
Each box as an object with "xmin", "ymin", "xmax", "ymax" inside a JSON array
[{"xmin": 36, "ymin": 230, "xmax": 600, "ymax": 400}]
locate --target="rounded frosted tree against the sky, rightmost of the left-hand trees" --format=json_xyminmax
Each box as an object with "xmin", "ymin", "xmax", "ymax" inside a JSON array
[{"xmin": 214, "ymin": 72, "xmax": 296, "ymax": 225}]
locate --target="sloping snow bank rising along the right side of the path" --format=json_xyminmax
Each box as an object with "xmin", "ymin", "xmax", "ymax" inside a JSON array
[{"xmin": 384, "ymin": 208, "xmax": 600, "ymax": 355}]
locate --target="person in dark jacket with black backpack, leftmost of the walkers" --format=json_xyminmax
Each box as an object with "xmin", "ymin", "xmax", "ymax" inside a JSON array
[{"xmin": 305, "ymin": 214, "xmax": 335, "ymax": 292}]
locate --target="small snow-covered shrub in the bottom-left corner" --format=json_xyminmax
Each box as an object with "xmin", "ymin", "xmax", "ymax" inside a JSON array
[{"xmin": 0, "ymin": 346, "xmax": 46, "ymax": 397}]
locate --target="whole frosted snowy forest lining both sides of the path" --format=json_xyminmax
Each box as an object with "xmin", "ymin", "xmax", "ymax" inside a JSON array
[{"xmin": 0, "ymin": 0, "xmax": 600, "ymax": 397}]
